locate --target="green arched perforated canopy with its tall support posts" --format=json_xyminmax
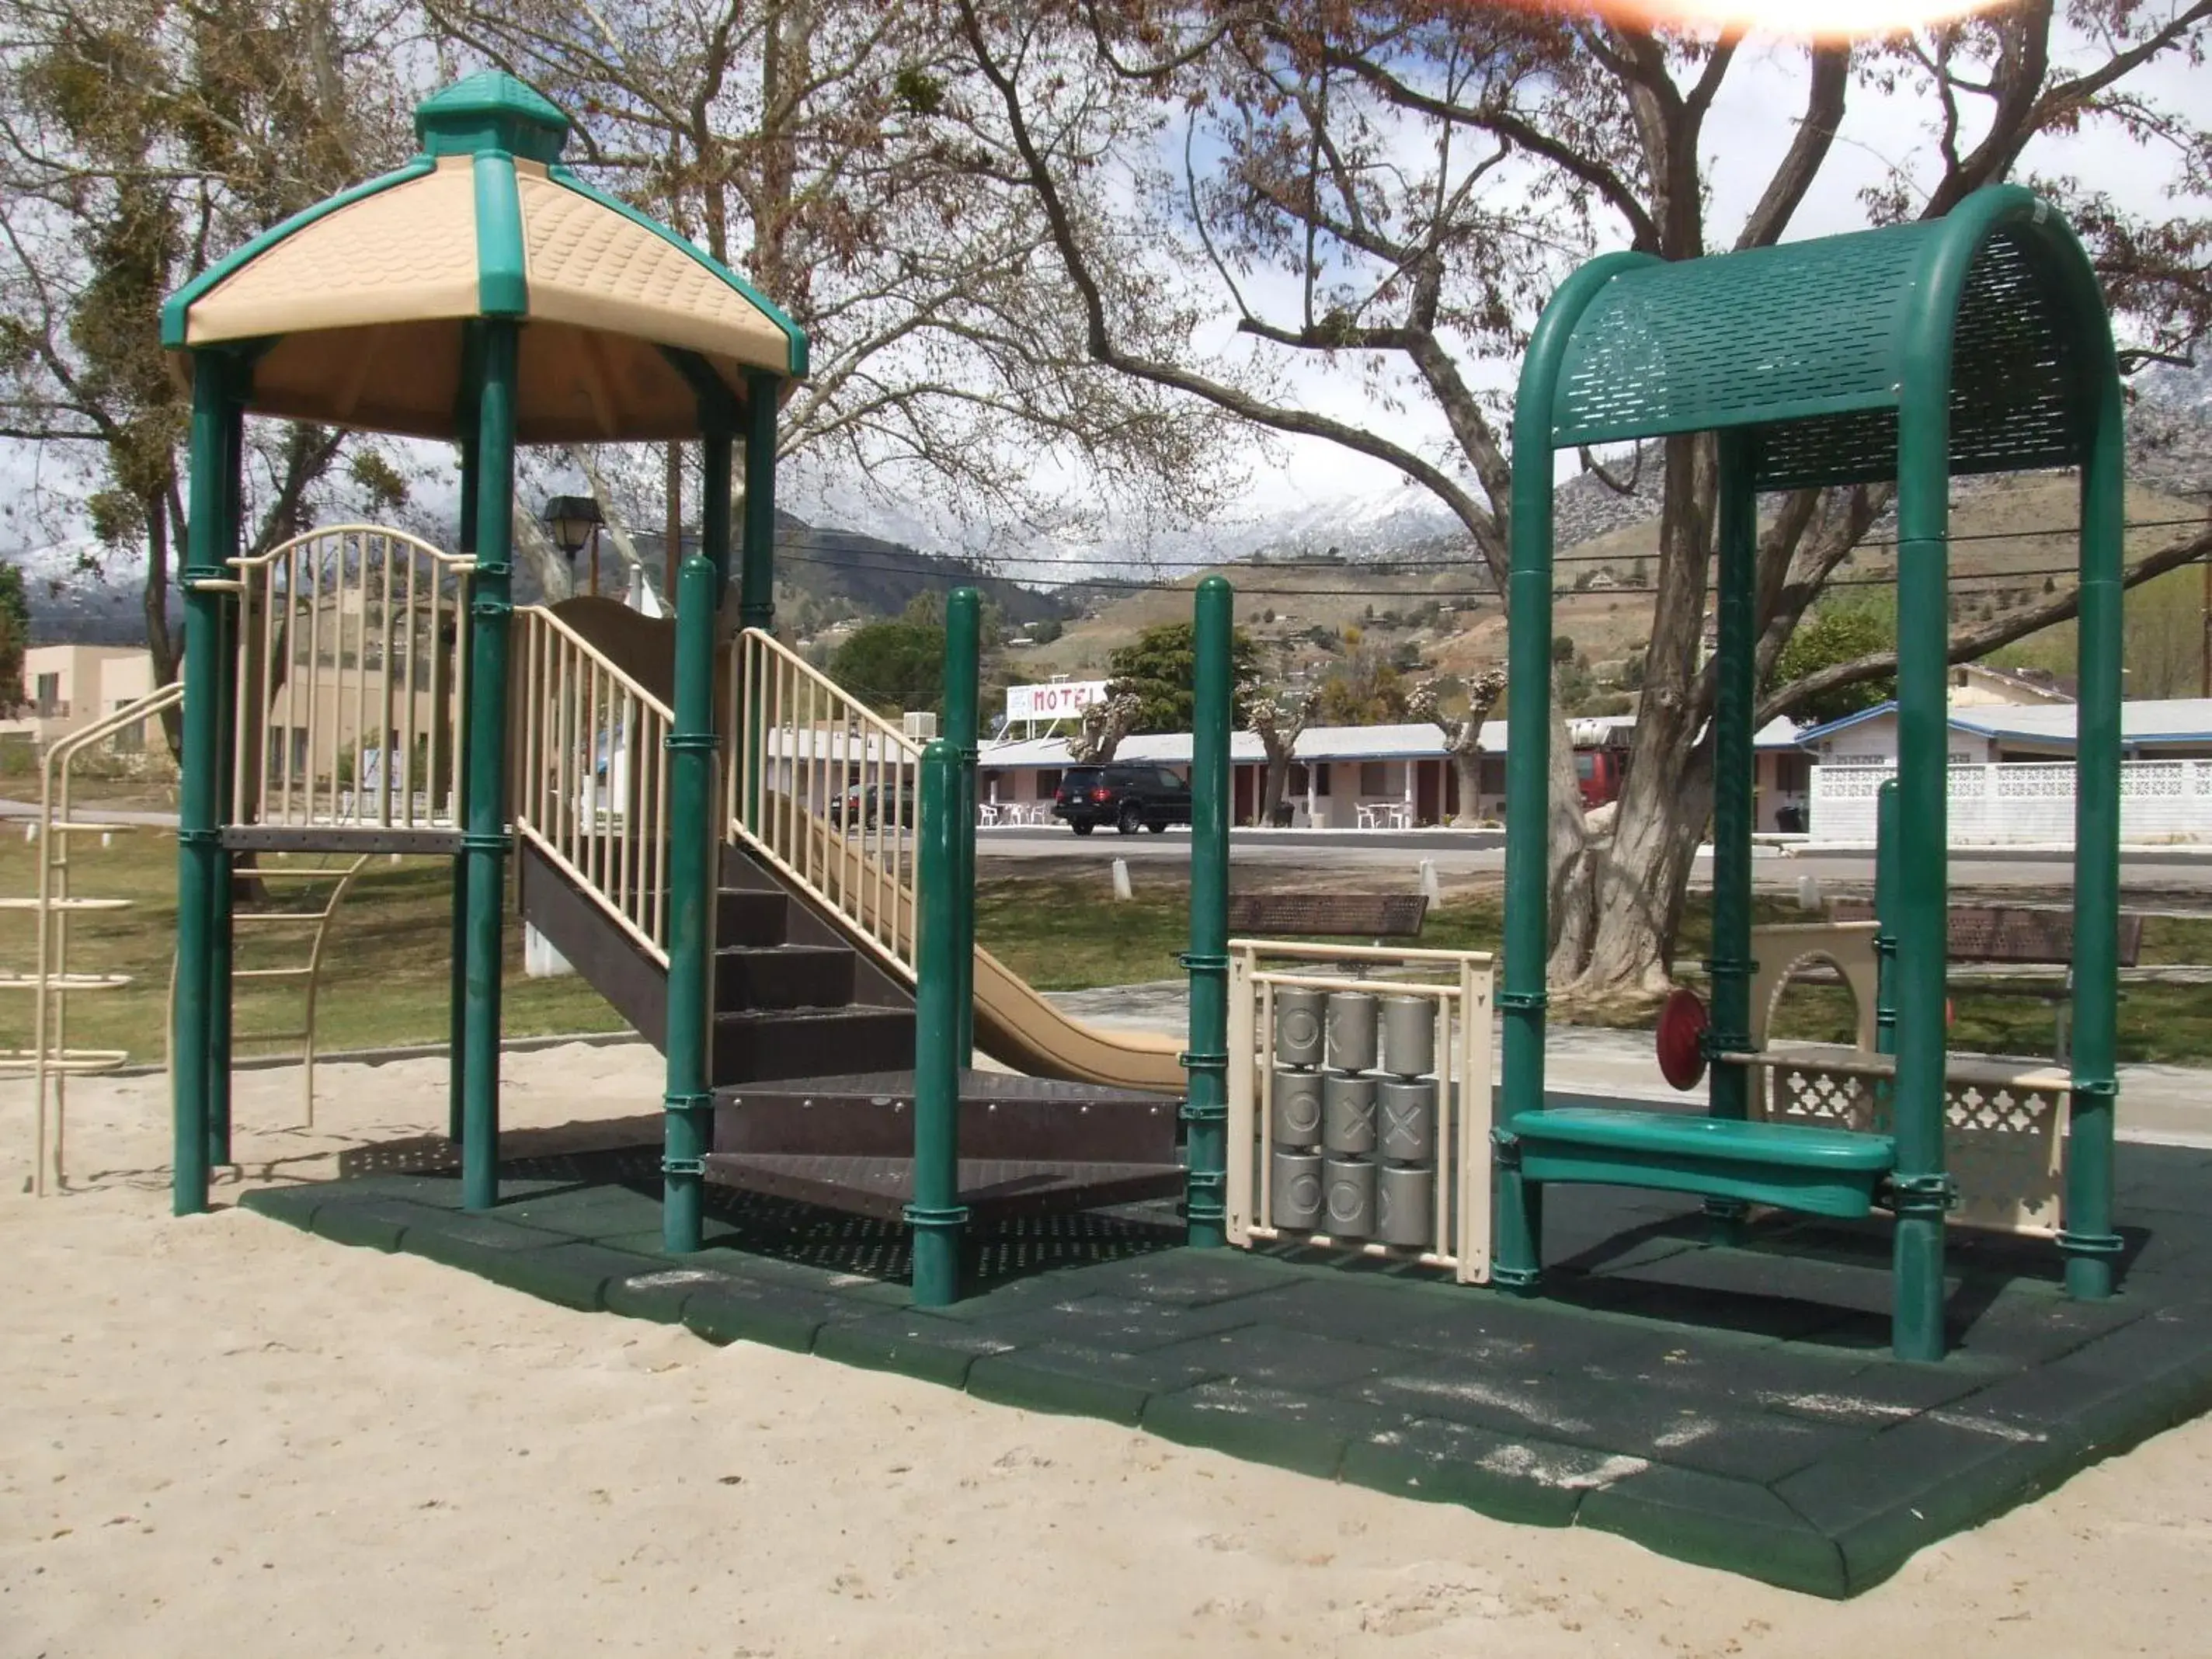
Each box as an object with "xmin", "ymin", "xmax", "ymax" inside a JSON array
[{"xmin": 1500, "ymin": 186, "xmax": 2123, "ymax": 1358}]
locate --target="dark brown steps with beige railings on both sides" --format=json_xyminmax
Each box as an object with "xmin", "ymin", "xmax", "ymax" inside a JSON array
[{"xmin": 513, "ymin": 602, "xmax": 1181, "ymax": 1221}]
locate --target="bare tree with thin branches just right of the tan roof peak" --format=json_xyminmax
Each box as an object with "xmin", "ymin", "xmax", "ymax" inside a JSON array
[{"xmin": 427, "ymin": 0, "xmax": 1229, "ymax": 559}]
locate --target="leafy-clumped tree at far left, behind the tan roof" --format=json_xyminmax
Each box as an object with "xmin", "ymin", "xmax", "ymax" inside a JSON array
[{"xmin": 0, "ymin": 0, "xmax": 409, "ymax": 746}]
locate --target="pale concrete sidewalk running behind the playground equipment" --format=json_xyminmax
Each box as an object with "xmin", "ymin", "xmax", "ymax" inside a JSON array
[{"xmin": 1049, "ymin": 980, "xmax": 2212, "ymax": 1148}]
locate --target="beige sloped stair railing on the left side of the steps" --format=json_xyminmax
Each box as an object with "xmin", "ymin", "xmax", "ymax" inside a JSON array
[{"xmin": 513, "ymin": 606, "xmax": 675, "ymax": 967}]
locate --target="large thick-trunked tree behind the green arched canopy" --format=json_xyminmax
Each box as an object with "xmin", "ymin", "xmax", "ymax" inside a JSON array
[{"xmin": 944, "ymin": 0, "xmax": 2212, "ymax": 1000}]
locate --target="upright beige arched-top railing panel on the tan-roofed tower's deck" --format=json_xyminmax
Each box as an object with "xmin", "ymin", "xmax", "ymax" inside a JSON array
[{"xmin": 210, "ymin": 524, "xmax": 475, "ymax": 830}]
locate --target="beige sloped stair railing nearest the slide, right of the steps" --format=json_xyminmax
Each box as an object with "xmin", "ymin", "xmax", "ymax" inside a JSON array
[{"xmin": 725, "ymin": 628, "xmax": 920, "ymax": 983}]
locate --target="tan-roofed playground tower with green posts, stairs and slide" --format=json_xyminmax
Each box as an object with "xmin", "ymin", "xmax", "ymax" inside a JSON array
[{"xmin": 162, "ymin": 73, "xmax": 1184, "ymax": 1282}]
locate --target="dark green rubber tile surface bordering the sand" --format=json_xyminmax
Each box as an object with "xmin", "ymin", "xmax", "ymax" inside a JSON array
[{"xmin": 241, "ymin": 1155, "xmax": 2212, "ymax": 1597}]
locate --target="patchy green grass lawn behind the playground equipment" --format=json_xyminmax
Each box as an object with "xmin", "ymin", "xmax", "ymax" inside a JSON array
[{"xmin": 12, "ymin": 827, "xmax": 2212, "ymax": 1064}]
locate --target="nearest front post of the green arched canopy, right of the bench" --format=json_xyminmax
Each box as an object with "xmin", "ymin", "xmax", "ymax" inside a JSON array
[{"xmin": 1889, "ymin": 350, "xmax": 1951, "ymax": 1361}]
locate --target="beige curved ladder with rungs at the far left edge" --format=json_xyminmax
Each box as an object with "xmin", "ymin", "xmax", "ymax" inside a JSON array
[{"xmin": 0, "ymin": 683, "xmax": 183, "ymax": 1197}]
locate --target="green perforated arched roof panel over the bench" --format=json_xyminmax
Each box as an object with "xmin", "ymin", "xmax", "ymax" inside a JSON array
[{"xmin": 1550, "ymin": 191, "xmax": 2102, "ymax": 489}]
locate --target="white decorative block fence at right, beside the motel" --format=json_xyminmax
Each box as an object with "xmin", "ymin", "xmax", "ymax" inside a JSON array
[{"xmin": 1807, "ymin": 761, "xmax": 2212, "ymax": 847}]
